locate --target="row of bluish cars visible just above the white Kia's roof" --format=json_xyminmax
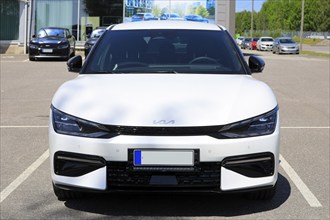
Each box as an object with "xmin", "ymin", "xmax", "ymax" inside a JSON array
[{"xmin": 131, "ymin": 13, "xmax": 209, "ymax": 23}]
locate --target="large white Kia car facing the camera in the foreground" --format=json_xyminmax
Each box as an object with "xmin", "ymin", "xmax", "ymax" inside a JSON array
[{"xmin": 49, "ymin": 21, "xmax": 280, "ymax": 200}]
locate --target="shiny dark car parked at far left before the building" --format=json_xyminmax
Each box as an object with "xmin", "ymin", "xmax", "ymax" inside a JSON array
[{"xmin": 29, "ymin": 27, "xmax": 76, "ymax": 61}]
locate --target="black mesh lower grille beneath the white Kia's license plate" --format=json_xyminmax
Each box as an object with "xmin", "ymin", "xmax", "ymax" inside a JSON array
[{"xmin": 107, "ymin": 162, "xmax": 221, "ymax": 189}]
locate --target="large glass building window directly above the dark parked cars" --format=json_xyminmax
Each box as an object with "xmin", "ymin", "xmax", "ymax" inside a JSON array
[{"xmin": 35, "ymin": 0, "xmax": 123, "ymax": 41}]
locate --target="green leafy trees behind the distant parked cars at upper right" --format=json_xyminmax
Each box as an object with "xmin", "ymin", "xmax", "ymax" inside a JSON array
[{"xmin": 236, "ymin": 0, "xmax": 330, "ymax": 33}]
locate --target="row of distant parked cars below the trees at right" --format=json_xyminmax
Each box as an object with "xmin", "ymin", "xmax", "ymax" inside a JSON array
[{"xmin": 236, "ymin": 37, "xmax": 299, "ymax": 54}]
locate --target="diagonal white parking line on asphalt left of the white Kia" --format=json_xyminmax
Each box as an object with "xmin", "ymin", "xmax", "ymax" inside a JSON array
[{"xmin": 0, "ymin": 150, "xmax": 49, "ymax": 203}]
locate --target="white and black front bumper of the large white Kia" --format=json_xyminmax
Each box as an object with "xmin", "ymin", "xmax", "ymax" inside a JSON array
[{"xmin": 49, "ymin": 113, "xmax": 279, "ymax": 192}]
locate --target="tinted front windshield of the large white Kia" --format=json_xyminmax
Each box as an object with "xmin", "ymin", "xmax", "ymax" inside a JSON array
[{"xmin": 82, "ymin": 30, "xmax": 246, "ymax": 74}]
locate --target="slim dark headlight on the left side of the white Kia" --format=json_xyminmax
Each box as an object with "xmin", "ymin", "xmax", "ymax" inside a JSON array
[{"xmin": 51, "ymin": 106, "xmax": 117, "ymax": 138}]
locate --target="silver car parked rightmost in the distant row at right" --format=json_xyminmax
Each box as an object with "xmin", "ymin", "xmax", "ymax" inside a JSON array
[{"xmin": 273, "ymin": 37, "xmax": 299, "ymax": 54}]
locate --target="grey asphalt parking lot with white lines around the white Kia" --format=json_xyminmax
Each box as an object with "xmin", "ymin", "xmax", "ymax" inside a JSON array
[{"xmin": 0, "ymin": 51, "xmax": 330, "ymax": 219}]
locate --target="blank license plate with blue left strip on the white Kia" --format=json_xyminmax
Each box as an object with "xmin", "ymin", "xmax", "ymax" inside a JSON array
[{"xmin": 134, "ymin": 150, "xmax": 194, "ymax": 166}]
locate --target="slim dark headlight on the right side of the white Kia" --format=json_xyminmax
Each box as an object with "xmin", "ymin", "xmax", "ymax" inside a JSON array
[{"xmin": 219, "ymin": 106, "xmax": 278, "ymax": 138}]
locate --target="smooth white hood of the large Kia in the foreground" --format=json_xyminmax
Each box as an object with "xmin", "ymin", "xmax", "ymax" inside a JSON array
[{"xmin": 52, "ymin": 74, "xmax": 277, "ymax": 126}]
